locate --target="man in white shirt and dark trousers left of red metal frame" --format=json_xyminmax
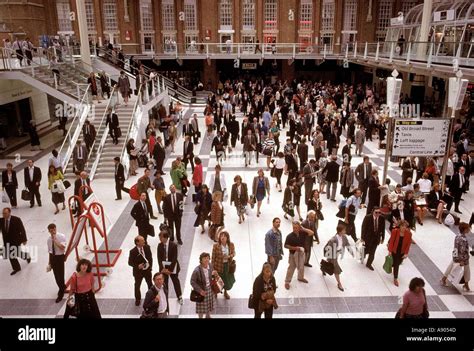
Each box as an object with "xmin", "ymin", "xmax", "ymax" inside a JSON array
[{"xmin": 47, "ymin": 223, "xmax": 66, "ymax": 303}]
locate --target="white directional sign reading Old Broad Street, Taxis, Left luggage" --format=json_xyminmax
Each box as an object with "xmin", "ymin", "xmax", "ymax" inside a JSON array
[{"xmin": 392, "ymin": 119, "xmax": 449, "ymax": 156}]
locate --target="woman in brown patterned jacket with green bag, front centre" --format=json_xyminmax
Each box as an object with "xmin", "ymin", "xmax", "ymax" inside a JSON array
[{"xmin": 212, "ymin": 231, "xmax": 235, "ymax": 300}]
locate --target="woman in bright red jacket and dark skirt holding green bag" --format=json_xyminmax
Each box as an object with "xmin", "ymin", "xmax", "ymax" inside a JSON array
[{"xmin": 388, "ymin": 220, "xmax": 412, "ymax": 286}]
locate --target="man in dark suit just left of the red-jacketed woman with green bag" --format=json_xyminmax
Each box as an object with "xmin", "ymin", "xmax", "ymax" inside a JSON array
[{"xmin": 362, "ymin": 206, "xmax": 385, "ymax": 271}]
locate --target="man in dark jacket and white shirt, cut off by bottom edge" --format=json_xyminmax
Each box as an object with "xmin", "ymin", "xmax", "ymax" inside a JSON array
[{"xmin": 143, "ymin": 273, "xmax": 169, "ymax": 319}]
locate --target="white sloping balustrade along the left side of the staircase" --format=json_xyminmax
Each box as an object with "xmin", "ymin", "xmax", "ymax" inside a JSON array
[{"xmin": 59, "ymin": 84, "xmax": 91, "ymax": 174}]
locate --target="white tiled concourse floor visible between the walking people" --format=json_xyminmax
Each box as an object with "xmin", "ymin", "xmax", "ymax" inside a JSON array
[{"xmin": 0, "ymin": 106, "xmax": 474, "ymax": 318}]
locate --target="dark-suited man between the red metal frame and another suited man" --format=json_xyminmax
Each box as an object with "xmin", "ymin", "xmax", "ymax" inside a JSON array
[{"xmin": 128, "ymin": 235, "xmax": 153, "ymax": 306}]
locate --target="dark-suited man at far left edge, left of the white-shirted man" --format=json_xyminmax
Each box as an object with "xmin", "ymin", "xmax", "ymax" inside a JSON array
[{"xmin": 0, "ymin": 207, "xmax": 31, "ymax": 275}]
